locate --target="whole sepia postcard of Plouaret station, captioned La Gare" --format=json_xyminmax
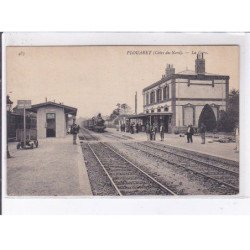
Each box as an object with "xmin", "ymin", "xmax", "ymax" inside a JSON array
[{"xmin": 5, "ymin": 43, "xmax": 240, "ymax": 197}]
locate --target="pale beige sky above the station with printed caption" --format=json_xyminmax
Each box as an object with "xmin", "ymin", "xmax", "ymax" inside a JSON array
[{"xmin": 6, "ymin": 46, "xmax": 239, "ymax": 117}]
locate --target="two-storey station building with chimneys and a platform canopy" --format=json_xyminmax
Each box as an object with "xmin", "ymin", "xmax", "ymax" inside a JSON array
[{"xmin": 133, "ymin": 53, "xmax": 229, "ymax": 133}]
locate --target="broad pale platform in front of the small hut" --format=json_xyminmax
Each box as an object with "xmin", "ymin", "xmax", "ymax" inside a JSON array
[{"xmin": 7, "ymin": 135, "xmax": 92, "ymax": 196}]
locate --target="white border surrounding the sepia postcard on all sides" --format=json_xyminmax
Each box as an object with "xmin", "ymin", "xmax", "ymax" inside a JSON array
[{"xmin": 2, "ymin": 32, "xmax": 250, "ymax": 214}]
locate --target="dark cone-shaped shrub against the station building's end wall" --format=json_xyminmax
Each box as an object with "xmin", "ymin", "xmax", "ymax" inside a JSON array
[{"xmin": 198, "ymin": 104, "xmax": 216, "ymax": 131}]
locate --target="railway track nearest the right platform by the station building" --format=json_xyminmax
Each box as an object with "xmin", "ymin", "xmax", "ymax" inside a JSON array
[{"xmin": 125, "ymin": 143, "xmax": 239, "ymax": 193}]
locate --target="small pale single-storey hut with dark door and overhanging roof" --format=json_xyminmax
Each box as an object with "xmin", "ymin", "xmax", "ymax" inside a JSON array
[{"xmin": 30, "ymin": 102, "xmax": 77, "ymax": 139}]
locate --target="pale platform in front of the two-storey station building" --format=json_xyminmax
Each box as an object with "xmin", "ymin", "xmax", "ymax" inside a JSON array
[{"xmin": 106, "ymin": 128, "xmax": 239, "ymax": 161}]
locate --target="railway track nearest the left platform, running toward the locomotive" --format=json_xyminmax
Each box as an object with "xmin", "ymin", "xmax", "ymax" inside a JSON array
[{"xmin": 86, "ymin": 142, "xmax": 176, "ymax": 196}]
